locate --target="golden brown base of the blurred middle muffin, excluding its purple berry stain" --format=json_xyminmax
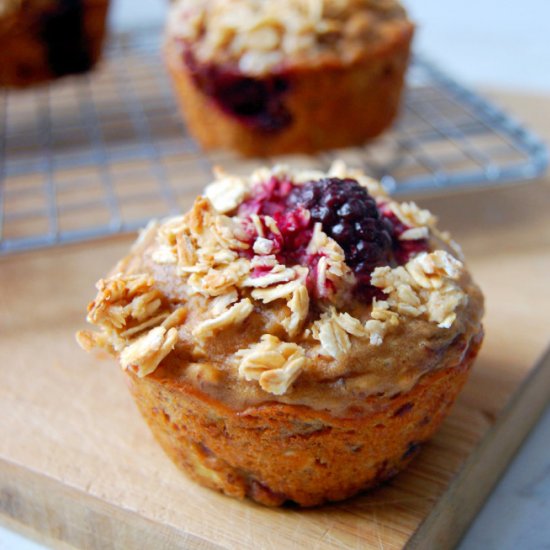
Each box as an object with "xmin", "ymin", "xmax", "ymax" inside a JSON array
[{"xmin": 167, "ymin": 24, "xmax": 413, "ymax": 156}]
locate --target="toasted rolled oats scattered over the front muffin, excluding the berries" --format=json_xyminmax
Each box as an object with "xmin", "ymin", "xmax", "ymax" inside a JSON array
[{"xmin": 78, "ymin": 163, "xmax": 467, "ymax": 395}]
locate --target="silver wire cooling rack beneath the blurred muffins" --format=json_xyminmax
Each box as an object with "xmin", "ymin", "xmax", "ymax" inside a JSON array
[{"xmin": 0, "ymin": 30, "xmax": 547, "ymax": 255}]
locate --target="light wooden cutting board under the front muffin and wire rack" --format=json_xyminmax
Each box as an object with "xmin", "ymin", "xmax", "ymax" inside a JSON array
[{"xmin": 0, "ymin": 92, "xmax": 550, "ymax": 549}]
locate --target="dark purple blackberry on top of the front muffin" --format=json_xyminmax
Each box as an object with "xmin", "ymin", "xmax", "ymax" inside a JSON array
[{"xmin": 288, "ymin": 178, "xmax": 393, "ymax": 278}]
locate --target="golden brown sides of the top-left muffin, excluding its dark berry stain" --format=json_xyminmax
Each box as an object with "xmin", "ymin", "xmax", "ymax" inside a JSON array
[{"xmin": 0, "ymin": 0, "xmax": 109, "ymax": 88}]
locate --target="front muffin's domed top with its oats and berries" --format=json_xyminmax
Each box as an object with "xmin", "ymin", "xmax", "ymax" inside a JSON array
[{"xmin": 78, "ymin": 163, "xmax": 483, "ymax": 411}]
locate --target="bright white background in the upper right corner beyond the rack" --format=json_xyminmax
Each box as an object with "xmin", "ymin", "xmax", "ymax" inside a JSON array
[{"xmin": 403, "ymin": 0, "xmax": 550, "ymax": 94}]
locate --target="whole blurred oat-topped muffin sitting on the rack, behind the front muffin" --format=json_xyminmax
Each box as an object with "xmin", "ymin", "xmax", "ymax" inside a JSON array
[{"xmin": 166, "ymin": 0, "xmax": 414, "ymax": 156}]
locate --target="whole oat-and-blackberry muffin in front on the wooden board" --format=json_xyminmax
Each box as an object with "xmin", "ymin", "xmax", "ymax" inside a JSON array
[{"xmin": 77, "ymin": 163, "xmax": 483, "ymax": 506}]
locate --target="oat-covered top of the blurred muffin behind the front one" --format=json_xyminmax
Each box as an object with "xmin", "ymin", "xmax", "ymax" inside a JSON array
[{"xmin": 168, "ymin": 0, "xmax": 412, "ymax": 76}]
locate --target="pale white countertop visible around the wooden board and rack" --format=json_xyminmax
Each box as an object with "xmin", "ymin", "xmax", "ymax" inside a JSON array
[{"xmin": 0, "ymin": 0, "xmax": 550, "ymax": 550}]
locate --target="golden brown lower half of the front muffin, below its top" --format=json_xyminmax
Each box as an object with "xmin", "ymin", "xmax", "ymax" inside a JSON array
[{"xmin": 128, "ymin": 334, "xmax": 482, "ymax": 506}]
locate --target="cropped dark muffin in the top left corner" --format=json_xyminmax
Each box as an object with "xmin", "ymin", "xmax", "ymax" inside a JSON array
[{"xmin": 0, "ymin": 0, "xmax": 109, "ymax": 87}]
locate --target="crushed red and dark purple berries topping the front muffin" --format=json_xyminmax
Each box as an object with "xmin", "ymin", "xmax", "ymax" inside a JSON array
[{"xmin": 239, "ymin": 176, "xmax": 428, "ymax": 301}]
